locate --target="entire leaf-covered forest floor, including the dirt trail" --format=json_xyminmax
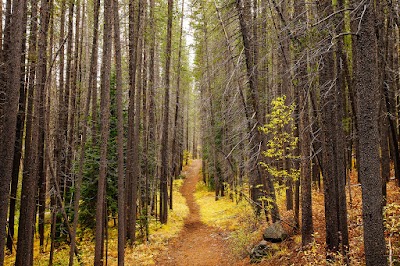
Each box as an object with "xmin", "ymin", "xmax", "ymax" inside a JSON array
[{"xmin": 4, "ymin": 160, "xmax": 400, "ymax": 266}]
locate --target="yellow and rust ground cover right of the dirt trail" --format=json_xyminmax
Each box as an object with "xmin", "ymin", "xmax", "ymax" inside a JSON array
[{"xmin": 195, "ymin": 173, "xmax": 400, "ymax": 266}]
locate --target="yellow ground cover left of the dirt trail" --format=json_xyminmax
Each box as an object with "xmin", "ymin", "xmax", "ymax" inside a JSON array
[{"xmin": 5, "ymin": 179, "xmax": 189, "ymax": 266}]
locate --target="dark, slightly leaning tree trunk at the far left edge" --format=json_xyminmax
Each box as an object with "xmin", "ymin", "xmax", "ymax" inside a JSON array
[{"xmin": 0, "ymin": 0, "xmax": 26, "ymax": 260}]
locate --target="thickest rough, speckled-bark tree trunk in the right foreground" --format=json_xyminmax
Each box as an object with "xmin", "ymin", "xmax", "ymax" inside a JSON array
[{"xmin": 353, "ymin": 1, "xmax": 387, "ymax": 266}]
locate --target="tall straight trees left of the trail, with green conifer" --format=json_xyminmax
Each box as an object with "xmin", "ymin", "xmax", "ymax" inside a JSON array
[{"xmin": 0, "ymin": 0, "xmax": 198, "ymax": 265}]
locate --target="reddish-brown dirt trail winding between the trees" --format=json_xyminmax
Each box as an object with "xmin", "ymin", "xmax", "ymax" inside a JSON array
[{"xmin": 156, "ymin": 160, "xmax": 234, "ymax": 266}]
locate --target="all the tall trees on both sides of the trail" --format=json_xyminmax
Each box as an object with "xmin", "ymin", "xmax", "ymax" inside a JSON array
[{"xmin": 0, "ymin": 0, "xmax": 400, "ymax": 265}]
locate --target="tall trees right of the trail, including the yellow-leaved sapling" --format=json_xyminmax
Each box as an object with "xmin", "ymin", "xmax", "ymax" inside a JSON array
[{"xmin": 193, "ymin": 0, "xmax": 399, "ymax": 265}]
